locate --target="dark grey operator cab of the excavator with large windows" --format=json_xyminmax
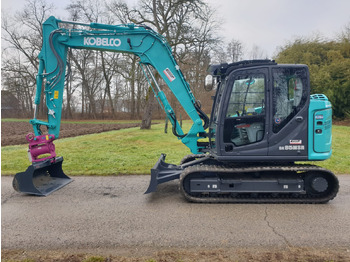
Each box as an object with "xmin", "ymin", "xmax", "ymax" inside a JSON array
[{"xmin": 209, "ymin": 60, "xmax": 310, "ymax": 161}]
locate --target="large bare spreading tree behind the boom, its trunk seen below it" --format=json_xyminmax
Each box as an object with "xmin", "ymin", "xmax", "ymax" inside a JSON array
[{"xmin": 109, "ymin": 0, "xmax": 220, "ymax": 129}]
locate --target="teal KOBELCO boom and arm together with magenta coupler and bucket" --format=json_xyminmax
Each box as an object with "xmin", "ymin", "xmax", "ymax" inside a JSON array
[{"xmin": 13, "ymin": 16, "xmax": 209, "ymax": 195}]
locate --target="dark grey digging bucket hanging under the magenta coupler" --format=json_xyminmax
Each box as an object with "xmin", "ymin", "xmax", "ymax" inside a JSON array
[{"xmin": 12, "ymin": 157, "xmax": 73, "ymax": 196}]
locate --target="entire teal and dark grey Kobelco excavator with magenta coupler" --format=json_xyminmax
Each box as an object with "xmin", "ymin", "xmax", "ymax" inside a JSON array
[{"xmin": 13, "ymin": 17, "xmax": 339, "ymax": 204}]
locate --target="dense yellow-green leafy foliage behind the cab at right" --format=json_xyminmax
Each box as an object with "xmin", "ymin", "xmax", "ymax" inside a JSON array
[{"xmin": 276, "ymin": 34, "xmax": 350, "ymax": 118}]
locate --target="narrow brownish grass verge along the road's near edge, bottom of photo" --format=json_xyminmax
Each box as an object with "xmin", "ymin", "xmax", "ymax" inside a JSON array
[{"xmin": 1, "ymin": 247, "xmax": 350, "ymax": 262}]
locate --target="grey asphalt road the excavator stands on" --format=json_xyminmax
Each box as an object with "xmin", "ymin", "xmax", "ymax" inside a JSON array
[{"xmin": 1, "ymin": 175, "xmax": 350, "ymax": 250}]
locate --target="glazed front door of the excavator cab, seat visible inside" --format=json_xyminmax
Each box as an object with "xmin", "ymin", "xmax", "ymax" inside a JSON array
[{"xmin": 220, "ymin": 68, "xmax": 269, "ymax": 156}]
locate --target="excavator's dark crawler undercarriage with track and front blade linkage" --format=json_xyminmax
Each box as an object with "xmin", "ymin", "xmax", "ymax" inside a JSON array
[{"xmin": 148, "ymin": 155, "xmax": 339, "ymax": 204}]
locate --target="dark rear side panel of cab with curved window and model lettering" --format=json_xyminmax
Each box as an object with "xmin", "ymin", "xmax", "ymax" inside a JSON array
[{"xmin": 268, "ymin": 65, "xmax": 310, "ymax": 157}]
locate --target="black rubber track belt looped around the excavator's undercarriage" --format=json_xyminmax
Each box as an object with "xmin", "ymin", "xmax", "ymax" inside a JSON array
[{"xmin": 180, "ymin": 165, "xmax": 339, "ymax": 204}]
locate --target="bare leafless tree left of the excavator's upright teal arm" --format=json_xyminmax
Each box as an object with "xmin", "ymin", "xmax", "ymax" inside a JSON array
[{"xmin": 1, "ymin": 0, "xmax": 54, "ymax": 115}]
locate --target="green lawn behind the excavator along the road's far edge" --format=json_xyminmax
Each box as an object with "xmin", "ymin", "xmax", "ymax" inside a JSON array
[{"xmin": 1, "ymin": 124, "xmax": 350, "ymax": 176}]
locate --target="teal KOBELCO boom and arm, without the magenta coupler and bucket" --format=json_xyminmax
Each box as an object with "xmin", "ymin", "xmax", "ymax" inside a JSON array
[{"xmin": 30, "ymin": 17, "xmax": 208, "ymax": 154}]
